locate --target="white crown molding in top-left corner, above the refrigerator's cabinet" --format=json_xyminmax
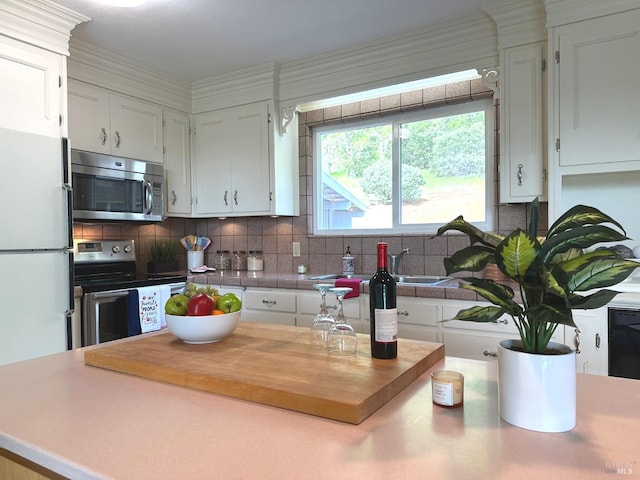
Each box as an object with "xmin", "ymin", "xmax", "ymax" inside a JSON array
[{"xmin": 0, "ymin": 0, "xmax": 91, "ymax": 55}]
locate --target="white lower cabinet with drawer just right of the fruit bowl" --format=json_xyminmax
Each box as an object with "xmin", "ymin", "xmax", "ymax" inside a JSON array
[{"xmin": 242, "ymin": 288, "xmax": 297, "ymax": 325}]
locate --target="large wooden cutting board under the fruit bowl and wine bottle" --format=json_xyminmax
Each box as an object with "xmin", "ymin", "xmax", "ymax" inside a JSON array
[{"xmin": 84, "ymin": 322, "xmax": 444, "ymax": 424}]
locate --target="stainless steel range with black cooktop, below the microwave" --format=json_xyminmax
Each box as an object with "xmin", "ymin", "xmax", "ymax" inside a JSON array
[{"xmin": 74, "ymin": 240, "xmax": 186, "ymax": 347}]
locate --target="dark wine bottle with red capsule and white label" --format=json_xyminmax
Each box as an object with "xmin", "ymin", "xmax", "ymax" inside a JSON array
[{"xmin": 369, "ymin": 242, "xmax": 398, "ymax": 359}]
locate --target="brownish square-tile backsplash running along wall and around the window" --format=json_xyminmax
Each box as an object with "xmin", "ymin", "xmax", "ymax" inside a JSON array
[{"xmin": 74, "ymin": 80, "xmax": 547, "ymax": 275}]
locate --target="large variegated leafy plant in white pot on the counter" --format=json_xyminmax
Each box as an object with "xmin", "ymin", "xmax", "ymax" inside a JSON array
[{"xmin": 436, "ymin": 199, "xmax": 638, "ymax": 432}]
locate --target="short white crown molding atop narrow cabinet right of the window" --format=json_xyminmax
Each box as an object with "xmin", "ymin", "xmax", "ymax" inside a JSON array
[{"xmin": 484, "ymin": 0, "xmax": 547, "ymax": 49}]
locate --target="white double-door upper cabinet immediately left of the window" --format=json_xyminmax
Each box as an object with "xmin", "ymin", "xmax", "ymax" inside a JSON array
[{"xmin": 192, "ymin": 102, "xmax": 299, "ymax": 217}]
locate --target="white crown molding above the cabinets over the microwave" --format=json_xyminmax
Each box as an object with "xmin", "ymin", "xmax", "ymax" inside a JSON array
[{"xmin": 67, "ymin": 38, "xmax": 191, "ymax": 113}]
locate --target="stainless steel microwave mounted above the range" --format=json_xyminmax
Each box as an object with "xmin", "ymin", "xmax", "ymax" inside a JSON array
[{"xmin": 71, "ymin": 149, "xmax": 164, "ymax": 222}]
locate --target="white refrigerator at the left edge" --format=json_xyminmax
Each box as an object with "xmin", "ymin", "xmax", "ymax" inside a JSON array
[{"xmin": 0, "ymin": 128, "xmax": 73, "ymax": 365}]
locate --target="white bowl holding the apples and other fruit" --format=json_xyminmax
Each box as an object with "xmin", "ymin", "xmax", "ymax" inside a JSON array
[{"xmin": 165, "ymin": 311, "xmax": 240, "ymax": 343}]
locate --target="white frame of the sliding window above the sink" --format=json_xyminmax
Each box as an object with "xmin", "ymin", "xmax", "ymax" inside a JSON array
[{"xmin": 312, "ymin": 98, "xmax": 497, "ymax": 236}]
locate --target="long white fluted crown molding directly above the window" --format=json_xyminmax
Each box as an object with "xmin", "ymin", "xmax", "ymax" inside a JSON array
[{"xmin": 279, "ymin": 15, "xmax": 498, "ymax": 106}]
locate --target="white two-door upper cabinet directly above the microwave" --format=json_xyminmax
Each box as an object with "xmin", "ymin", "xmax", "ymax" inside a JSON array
[{"xmin": 68, "ymin": 81, "xmax": 163, "ymax": 163}]
